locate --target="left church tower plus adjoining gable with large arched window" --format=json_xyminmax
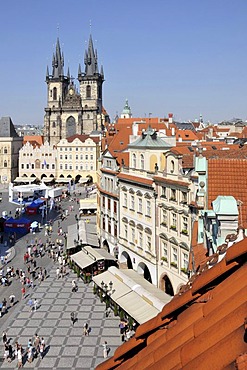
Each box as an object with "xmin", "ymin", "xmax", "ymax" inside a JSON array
[{"xmin": 44, "ymin": 39, "xmax": 82, "ymax": 145}]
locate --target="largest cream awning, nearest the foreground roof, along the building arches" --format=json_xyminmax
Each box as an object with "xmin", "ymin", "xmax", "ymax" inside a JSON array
[{"xmin": 93, "ymin": 266, "xmax": 172, "ymax": 324}]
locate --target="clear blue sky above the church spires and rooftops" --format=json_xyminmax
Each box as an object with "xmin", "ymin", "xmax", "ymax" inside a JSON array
[{"xmin": 0, "ymin": 0, "xmax": 247, "ymax": 125}]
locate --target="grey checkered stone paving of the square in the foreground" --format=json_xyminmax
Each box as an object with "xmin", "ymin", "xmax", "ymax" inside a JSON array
[{"xmin": 0, "ymin": 265, "xmax": 121, "ymax": 370}]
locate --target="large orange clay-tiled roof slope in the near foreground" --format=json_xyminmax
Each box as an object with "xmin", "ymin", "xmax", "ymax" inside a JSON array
[{"xmin": 96, "ymin": 238, "xmax": 247, "ymax": 370}]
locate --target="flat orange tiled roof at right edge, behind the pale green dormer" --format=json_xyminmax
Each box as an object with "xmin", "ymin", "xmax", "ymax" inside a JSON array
[{"xmin": 208, "ymin": 158, "xmax": 247, "ymax": 228}]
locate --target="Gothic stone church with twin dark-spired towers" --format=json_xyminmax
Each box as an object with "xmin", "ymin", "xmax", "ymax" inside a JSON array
[{"xmin": 44, "ymin": 35, "xmax": 104, "ymax": 145}]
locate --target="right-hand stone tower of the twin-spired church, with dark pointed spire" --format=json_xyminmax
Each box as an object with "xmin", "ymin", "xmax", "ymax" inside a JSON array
[{"xmin": 78, "ymin": 35, "xmax": 104, "ymax": 134}]
